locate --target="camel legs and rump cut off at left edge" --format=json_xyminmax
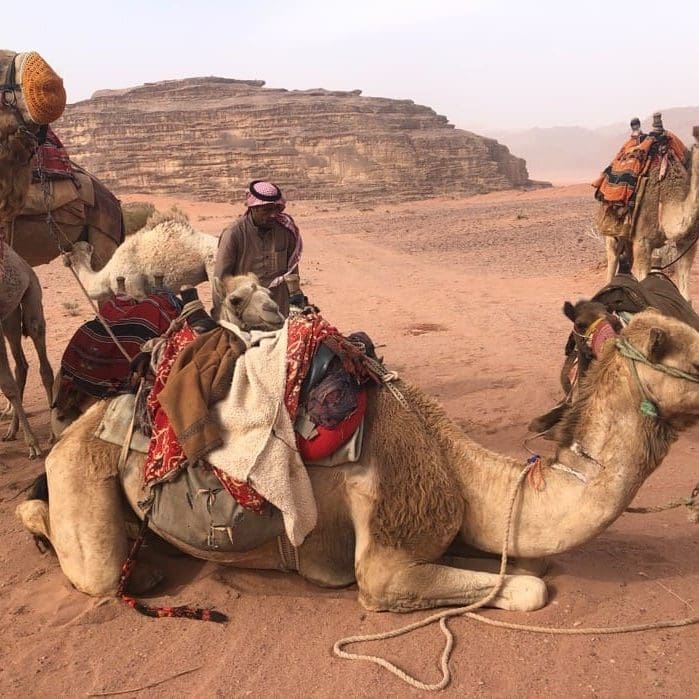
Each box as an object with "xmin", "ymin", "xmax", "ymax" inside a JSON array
[{"xmin": 0, "ymin": 242, "xmax": 53, "ymax": 458}]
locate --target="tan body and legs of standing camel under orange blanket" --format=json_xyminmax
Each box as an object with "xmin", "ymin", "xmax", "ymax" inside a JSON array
[{"xmin": 596, "ymin": 121, "xmax": 699, "ymax": 300}]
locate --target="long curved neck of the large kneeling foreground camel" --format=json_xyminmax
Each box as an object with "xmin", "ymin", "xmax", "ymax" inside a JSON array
[{"xmin": 453, "ymin": 362, "xmax": 674, "ymax": 557}]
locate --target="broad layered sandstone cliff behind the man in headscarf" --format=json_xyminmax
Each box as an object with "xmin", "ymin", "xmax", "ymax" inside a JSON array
[{"xmin": 54, "ymin": 77, "xmax": 535, "ymax": 202}]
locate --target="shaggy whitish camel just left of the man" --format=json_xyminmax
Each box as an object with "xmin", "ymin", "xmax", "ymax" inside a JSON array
[{"xmin": 66, "ymin": 214, "xmax": 218, "ymax": 301}]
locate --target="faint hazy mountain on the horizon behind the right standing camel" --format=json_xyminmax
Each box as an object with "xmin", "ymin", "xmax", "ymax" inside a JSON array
[{"xmin": 483, "ymin": 107, "xmax": 699, "ymax": 184}]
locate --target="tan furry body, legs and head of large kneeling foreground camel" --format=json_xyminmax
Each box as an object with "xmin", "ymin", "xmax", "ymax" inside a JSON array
[{"xmin": 17, "ymin": 310, "xmax": 699, "ymax": 612}]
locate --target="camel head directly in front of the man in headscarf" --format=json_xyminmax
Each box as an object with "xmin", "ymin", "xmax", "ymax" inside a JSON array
[{"xmin": 213, "ymin": 274, "xmax": 284, "ymax": 330}]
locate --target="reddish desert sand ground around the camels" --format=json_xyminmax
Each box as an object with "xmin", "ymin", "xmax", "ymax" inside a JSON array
[{"xmin": 0, "ymin": 185, "xmax": 699, "ymax": 697}]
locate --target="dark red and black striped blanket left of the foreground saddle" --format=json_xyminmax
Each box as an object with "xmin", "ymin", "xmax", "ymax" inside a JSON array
[{"xmin": 61, "ymin": 292, "xmax": 182, "ymax": 398}]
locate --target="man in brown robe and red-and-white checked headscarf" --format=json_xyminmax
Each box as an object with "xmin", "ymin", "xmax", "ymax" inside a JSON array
[{"xmin": 214, "ymin": 180, "xmax": 306, "ymax": 316}]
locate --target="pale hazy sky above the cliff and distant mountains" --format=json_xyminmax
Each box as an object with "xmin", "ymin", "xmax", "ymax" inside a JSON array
[{"xmin": 6, "ymin": 0, "xmax": 699, "ymax": 131}]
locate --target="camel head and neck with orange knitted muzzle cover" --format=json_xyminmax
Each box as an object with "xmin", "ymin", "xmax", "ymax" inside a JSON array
[{"xmin": 0, "ymin": 51, "xmax": 66, "ymax": 222}]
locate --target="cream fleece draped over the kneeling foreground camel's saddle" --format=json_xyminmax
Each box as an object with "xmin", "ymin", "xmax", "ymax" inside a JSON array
[{"xmin": 207, "ymin": 321, "xmax": 317, "ymax": 546}]
